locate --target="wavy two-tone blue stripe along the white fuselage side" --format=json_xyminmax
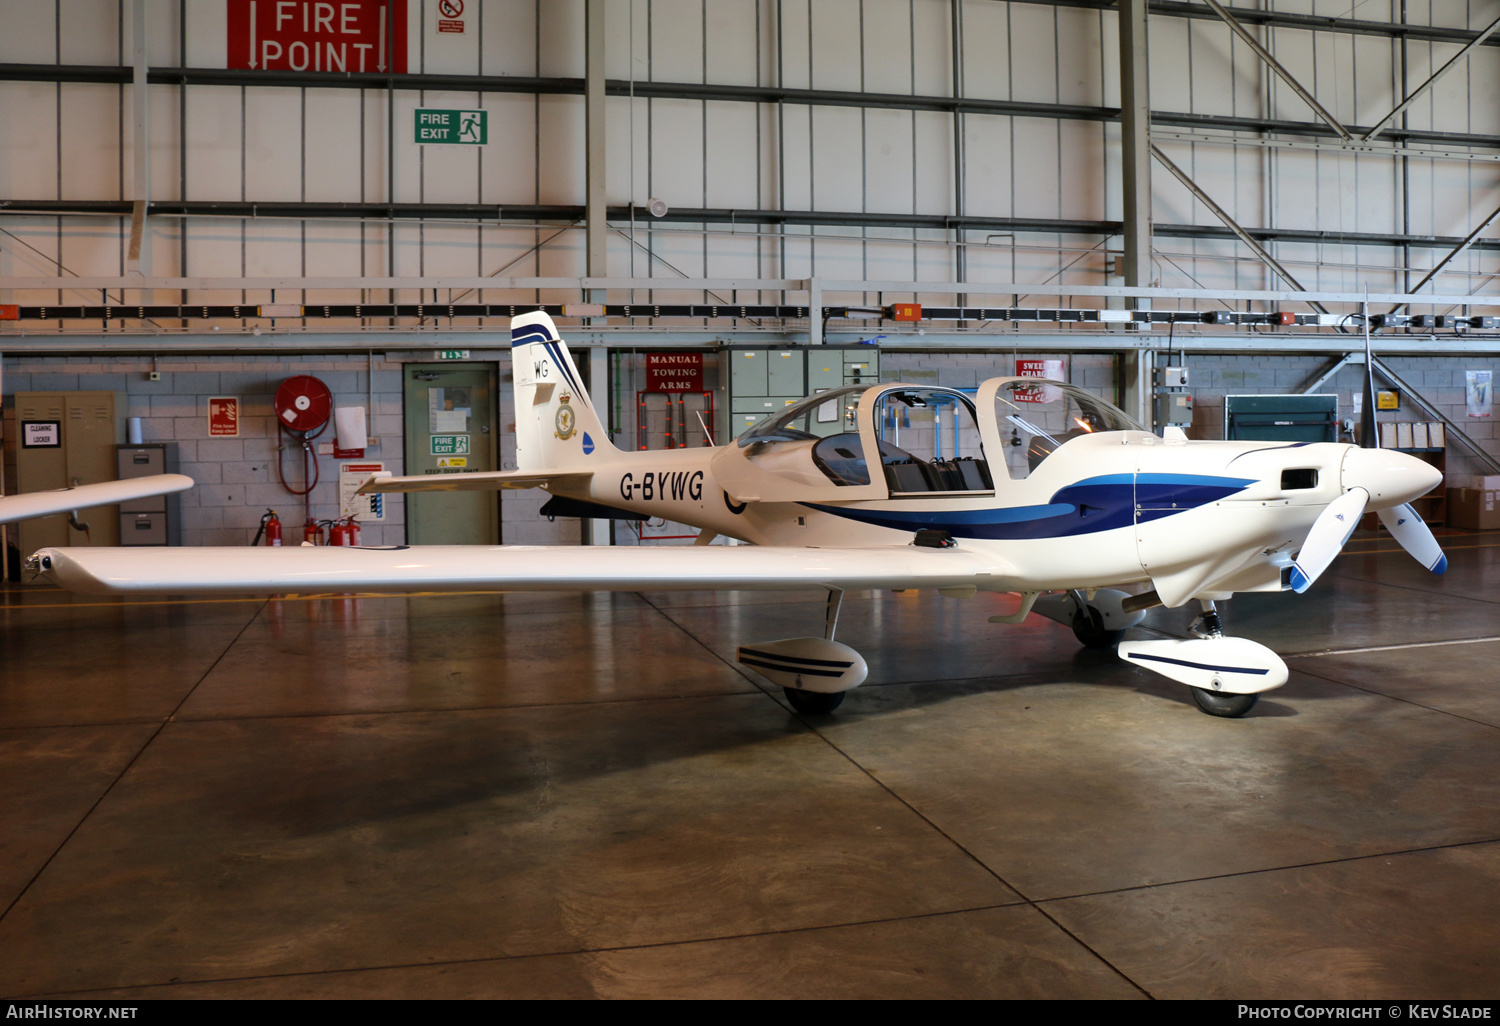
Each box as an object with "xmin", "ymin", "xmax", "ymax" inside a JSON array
[{"xmin": 803, "ymin": 474, "xmax": 1254, "ymax": 540}]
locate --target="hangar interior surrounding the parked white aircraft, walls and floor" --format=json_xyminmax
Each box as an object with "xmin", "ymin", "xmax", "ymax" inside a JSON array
[{"xmin": 0, "ymin": 0, "xmax": 1500, "ymax": 999}]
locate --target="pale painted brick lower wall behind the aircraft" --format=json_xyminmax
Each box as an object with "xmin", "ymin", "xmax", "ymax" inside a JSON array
[{"xmin": 3, "ymin": 351, "xmax": 1500, "ymax": 545}]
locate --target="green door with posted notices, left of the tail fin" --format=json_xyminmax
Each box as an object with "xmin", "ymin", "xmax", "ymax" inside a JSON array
[{"xmin": 405, "ymin": 363, "xmax": 500, "ymax": 545}]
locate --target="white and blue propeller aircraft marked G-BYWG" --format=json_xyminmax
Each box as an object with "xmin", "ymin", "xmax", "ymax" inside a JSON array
[{"xmin": 27, "ymin": 312, "xmax": 1448, "ymax": 717}]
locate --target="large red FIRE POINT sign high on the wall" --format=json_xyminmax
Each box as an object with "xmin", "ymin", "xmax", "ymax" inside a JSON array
[{"xmin": 228, "ymin": 0, "xmax": 407, "ymax": 75}]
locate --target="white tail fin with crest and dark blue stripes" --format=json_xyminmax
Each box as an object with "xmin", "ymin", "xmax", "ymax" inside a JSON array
[{"xmin": 510, "ymin": 311, "xmax": 615, "ymax": 471}]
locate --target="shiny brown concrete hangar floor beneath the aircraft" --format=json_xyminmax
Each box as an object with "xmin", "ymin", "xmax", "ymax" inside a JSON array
[{"xmin": 0, "ymin": 533, "xmax": 1500, "ymax": 999}]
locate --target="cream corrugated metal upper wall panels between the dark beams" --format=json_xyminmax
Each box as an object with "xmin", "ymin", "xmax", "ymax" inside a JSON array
[{"xmin": 0, "ymin": 0, "xmax": 1500, "ymax": 316}]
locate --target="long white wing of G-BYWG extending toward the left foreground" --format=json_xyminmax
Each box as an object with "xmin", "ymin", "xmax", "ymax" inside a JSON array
[{"xmin": 27, "ymin": 545, "xmax": 1017, "ymax": 594}]
